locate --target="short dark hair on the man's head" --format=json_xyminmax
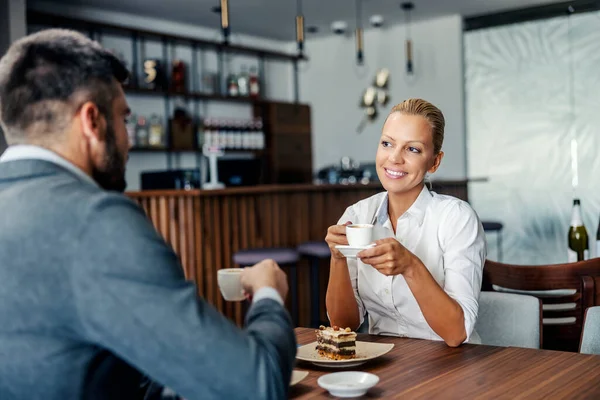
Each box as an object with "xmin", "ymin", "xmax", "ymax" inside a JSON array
[{"xmin": 0, "ymin": 29, "xmax": 129, "ymax": 144}]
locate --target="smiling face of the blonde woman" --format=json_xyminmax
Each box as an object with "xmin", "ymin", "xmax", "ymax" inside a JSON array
[{"xmin": 375, "ymin": 112, "xmax": 443, "ymax": 194}]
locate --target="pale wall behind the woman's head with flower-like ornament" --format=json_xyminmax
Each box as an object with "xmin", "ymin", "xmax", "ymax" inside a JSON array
[{"xmin": 300, "ymin": 15, "xmax": 466, "ymax": 179}]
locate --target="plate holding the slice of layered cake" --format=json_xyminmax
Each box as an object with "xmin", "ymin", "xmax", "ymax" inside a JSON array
[{"xmin": 296, "ymin": 341, "xmax": 394, "ymax": 368}]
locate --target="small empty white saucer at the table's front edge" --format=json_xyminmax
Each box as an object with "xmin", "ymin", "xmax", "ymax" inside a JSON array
[{"xmin": 317, "ymin": 371, "xmax": 379, "ymax": 398}]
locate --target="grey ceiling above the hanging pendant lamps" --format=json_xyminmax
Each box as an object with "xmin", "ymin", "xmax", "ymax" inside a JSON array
[{"xmin": 50, "ymin": 0, "xmax": 564, "ymax": 40}]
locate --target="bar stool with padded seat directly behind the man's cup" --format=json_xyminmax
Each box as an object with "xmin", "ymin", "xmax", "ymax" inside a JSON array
[{"xmin": 233, "ymin": 247, "xmax": 300, "ymax": 325}]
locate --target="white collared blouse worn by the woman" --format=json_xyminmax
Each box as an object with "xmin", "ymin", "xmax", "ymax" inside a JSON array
[{"xmin": 338, "ymin": 187, "xmax": 487, "ymax": 343}]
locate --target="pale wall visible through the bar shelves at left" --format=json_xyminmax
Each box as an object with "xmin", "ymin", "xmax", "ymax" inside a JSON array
[{"xmin": 29, "ymin": 0, "xmax": 293, "ymax": 191}]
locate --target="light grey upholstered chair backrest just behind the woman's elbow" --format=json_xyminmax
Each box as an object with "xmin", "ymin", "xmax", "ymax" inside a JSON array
[{"xmin": 475, "ymin": 292, "xmax": 542, "ymax": 349}]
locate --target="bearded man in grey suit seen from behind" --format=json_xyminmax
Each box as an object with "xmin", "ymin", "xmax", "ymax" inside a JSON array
[{"xmin": 0, "ymin": 30, "xmax": 296, "ymax": 400}]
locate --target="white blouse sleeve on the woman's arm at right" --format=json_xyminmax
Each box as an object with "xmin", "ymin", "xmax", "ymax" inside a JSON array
[{"xmin": 440, "ymin": 202, "xmax": 487, "ymax": 342}]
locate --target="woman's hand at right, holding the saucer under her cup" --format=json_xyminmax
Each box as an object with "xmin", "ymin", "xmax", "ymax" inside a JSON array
[{"xmin": 356, "ymin": 238, "xmax": 416, "ymax": 276}]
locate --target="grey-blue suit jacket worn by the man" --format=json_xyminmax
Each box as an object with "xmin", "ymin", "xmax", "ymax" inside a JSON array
[{"xmin": 0, "ymin": 160, "xmax": 296, "ymax": 400}]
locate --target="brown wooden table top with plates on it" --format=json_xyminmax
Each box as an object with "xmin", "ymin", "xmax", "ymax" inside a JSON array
[{"xmin": 290, "ymin": 328, "xmax": 600, "ymax": 399}]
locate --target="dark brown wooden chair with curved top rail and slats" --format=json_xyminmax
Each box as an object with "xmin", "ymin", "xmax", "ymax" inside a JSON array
[{"xmin": 482, "ymin": 258, "xmax": 600, "ymax": 352}]
